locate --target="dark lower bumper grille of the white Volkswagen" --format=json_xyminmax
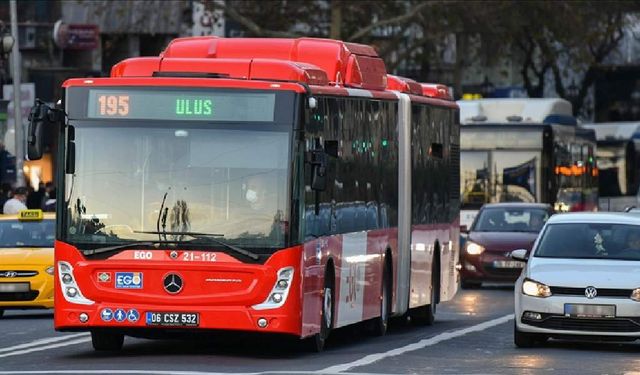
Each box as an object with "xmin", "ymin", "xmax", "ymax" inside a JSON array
[{"xmin": 523, "ymin": 316, "xmax": 640, "ymax": 332}]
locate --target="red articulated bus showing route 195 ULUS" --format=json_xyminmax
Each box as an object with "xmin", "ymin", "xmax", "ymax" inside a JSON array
[{"xmin": 28, "ymin": 37, "xmax": 460, "ymax": 350}]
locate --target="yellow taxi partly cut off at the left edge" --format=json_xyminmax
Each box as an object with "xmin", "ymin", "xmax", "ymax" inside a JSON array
[{"xmin": 0, "ymin": 210, "xmax": 55, "ymax": 317}]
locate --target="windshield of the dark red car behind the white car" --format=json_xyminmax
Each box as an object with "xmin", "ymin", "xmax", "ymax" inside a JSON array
[{"xmin": 471, "ymin": 207, "xmax": 549, "ymax": 233}]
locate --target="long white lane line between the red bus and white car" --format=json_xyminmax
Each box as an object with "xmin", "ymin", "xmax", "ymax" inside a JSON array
[{"xmin": 316, "ymin": 314, "xmax": 513, "ymax": 374}]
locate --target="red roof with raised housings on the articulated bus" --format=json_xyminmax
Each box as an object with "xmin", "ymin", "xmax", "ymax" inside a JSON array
[{"xmin": 63, "ymin": 36, "xmax": 458, "ymax": 109}]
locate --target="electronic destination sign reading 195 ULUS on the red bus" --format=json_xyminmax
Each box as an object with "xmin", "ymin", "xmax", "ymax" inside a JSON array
[{"xmin": 87, "ymin": 89, "xmax": 275, "ymax": 122}]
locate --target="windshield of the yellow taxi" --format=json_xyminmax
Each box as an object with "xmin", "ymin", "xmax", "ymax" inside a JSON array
[{"xmin": 0, "ymin": 220, "xmax": 55, "ymax": 248}]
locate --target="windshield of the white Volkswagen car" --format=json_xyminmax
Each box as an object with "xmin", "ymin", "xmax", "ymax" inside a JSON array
[{"xmin": 535, "ymin": 223, "xmax": 640, "ymax": 260}]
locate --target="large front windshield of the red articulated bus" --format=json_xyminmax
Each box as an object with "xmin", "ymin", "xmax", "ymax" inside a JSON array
[{"xmin": 63, "ymin": 120, "xmax": 291, "ymax": 250}]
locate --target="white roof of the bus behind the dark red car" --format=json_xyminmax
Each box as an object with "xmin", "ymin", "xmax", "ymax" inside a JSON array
[{"xmin": 458, "ymin": 98, "xmax": 577, "ymax": 125}]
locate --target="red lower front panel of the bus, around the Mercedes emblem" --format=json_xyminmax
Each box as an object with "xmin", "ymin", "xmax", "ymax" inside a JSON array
[{"xmin": 54, "ymin": 241, "xmax": 302, "ymax": 336}]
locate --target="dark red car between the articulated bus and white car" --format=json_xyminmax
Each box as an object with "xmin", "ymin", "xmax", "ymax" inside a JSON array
[{"xmin": 460, "ymin": 203, "xmax": 553, "ymax": 288}]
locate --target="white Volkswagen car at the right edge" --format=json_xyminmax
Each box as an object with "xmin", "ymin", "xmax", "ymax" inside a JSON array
[{"xmin": 511, "ymin": 213, "xmax": 640, "ymax": 347}]
